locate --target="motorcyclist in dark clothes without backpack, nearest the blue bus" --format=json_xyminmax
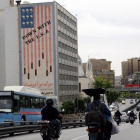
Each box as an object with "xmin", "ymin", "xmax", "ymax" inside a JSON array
[{"xmin": 41, "ymin": 99, "xmax": 62, "ymax": 138}]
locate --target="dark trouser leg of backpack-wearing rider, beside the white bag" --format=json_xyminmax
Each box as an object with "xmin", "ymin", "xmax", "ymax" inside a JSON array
[{"xmin": 104, "ymin": 120, "xmax": 112, "ymax": 139}]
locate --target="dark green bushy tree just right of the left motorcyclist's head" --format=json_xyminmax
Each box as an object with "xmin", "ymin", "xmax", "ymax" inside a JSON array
[{"xmin": 61, "ymin": 101, "xmax": 74, "ymax": 114}]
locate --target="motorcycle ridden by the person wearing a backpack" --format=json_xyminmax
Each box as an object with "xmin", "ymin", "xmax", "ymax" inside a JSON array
[{"xmin": 86, "ymin": 122, "xmax": 105, "ymax": 140}]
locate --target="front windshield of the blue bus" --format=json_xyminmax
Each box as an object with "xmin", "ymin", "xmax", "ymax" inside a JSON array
[{"xmin": 0, "ymin": 98, "xmax": 12, "ymax": 112}]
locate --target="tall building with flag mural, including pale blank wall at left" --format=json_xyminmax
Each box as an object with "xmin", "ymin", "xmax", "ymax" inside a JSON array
[{"xmin": 0, "ymin": 0, "xmax": 79, "ymax": 102}]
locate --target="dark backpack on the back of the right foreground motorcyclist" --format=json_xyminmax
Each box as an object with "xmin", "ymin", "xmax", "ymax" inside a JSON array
[{"xmin": 85, "ymin": 103, "xmax": 106, "ymax": 125}]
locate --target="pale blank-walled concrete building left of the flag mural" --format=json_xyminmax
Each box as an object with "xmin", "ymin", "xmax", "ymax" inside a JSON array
[{"xmin": 0, "ymin": 0, "xmax": 20, "ymax": 90}]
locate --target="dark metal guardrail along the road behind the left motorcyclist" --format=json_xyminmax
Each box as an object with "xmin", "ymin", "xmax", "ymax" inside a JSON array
[{"xmin": 0, "ymin": 120, "xmax": 85, "ymax": 136}]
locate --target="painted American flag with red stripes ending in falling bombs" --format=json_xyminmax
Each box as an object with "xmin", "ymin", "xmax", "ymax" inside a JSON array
[{"xmin": 20, "ymin": 6, "xmax": 53, "ymax": 79}]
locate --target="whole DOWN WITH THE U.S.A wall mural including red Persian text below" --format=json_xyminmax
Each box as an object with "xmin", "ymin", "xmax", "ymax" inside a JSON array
[{"xmin": 19, "ymin": 4, "xmax": 56, "ymax": 95}]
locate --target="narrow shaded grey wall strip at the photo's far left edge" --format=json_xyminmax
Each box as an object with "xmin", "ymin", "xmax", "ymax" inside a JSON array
[{"xmin": 0, "ymin": 10, "xmax": 6, "ymax": 90}]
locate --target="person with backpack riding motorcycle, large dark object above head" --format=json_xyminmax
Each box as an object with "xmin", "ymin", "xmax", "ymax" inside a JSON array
[{"xmin": 86, "ymin": 94, "xmax": 112, "ymax": 140}]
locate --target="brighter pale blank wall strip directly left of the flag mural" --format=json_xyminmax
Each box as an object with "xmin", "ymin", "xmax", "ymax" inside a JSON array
[{"xmin": 5, "ymin": 7, "xmax": 19, "ymax": 86}]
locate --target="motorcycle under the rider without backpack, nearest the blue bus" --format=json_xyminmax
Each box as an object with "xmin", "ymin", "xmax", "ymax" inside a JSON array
[{"xmin": 38, "ymin": 120, "xmax": 58, "ymax": 140}]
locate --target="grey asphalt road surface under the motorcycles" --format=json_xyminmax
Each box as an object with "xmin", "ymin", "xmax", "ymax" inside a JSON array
[{"xmin": 0, "ymin": 100, "xmax": 140, "ymax": 140}]
